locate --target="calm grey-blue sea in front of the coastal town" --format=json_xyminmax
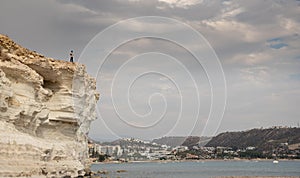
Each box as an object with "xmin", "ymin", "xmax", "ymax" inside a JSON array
[{"xmin": 91, "ymin": 160, "xmax": 300, "ymax": 178}]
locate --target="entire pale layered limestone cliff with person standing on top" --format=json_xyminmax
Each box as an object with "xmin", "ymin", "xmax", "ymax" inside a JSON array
[{"xmin": 0, "ymin": 35, "xmax": 99, "ymax": 177}]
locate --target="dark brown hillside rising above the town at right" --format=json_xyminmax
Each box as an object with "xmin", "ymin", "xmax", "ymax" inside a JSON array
[{"xmin": 205, "ymin": 127, "xmax": 300, "ymax": 151}]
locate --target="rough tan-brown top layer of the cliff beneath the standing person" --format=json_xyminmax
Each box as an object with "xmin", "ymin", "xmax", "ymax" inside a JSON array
[{"xmin": 0, "ymin": 34, "xmax": 95, "ymax": 82}]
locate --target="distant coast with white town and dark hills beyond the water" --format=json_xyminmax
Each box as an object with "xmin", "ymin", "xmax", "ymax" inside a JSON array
[{"xmin": 89, "ymin": 126, "xmax": 300, "ymax": 162}]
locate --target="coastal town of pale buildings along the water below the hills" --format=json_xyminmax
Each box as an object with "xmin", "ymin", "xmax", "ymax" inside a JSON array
[{"xmin": 89, "ymin": 127, "xmax": 300, "ymax": 162}]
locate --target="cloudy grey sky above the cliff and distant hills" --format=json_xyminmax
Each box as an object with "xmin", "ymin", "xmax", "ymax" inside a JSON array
[{"xmin": 0, "ymin": 0, "xmax": 300, "ymax": 140}]
